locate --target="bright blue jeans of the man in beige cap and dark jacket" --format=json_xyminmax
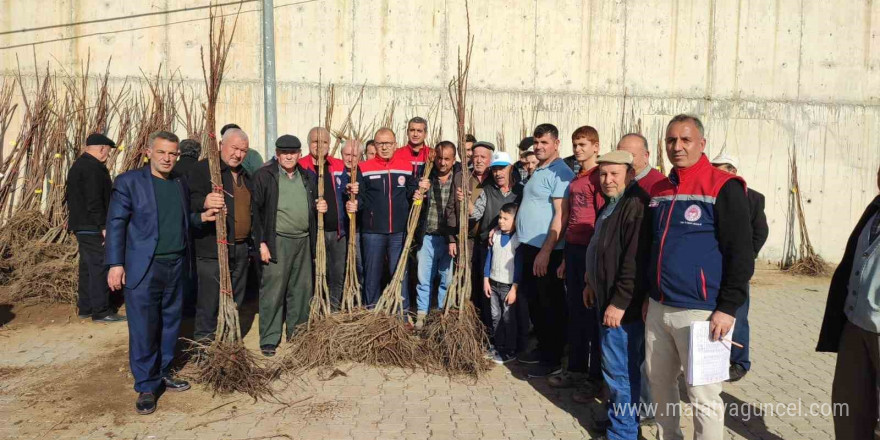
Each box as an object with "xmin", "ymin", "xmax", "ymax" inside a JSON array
[{"xmin": 601, "ymin": 320, "xmax": 645, "ymax": 440}]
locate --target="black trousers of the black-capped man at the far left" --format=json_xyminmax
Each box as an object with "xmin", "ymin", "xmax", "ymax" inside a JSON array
[{"xmin": 76, "ymin": 232, "xmax": 112, "ymax": 319}]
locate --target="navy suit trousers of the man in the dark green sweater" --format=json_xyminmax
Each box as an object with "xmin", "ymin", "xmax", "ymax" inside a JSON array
[{"xmin": 125, "ymin": 257, "xmax": 186, "ymax": 393}]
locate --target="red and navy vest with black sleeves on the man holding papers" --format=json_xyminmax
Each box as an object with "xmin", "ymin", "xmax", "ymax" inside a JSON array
[{"xmin": 648, "ymin": 155, "xmax": 755, "ymax": 316}]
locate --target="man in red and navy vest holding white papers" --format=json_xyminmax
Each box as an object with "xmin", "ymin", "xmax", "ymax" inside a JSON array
[{"xmin": 645, "ymin": 115, "xmax": 755, "ymax": 440}]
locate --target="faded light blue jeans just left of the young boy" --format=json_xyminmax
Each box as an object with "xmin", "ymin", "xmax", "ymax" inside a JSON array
[{"xmin": 416, "ymin": 235, "xmax": 452, "ymax": 312}]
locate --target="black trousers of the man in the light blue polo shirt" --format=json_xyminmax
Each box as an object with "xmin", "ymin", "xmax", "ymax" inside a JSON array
[{"xmin": 517, "ymin": 244, "xmax": 567, "ymax": 365}]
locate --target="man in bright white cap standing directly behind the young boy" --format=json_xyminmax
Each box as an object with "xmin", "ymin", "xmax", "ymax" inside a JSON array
[{"xmin": 470, "ymin": 149, "xmax": 522, "ymax": 342}]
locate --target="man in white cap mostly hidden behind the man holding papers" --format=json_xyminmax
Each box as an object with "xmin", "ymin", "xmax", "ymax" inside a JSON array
[{"xmin": 712, "ymin": 153, "xmax": 770, "ymax": 382}]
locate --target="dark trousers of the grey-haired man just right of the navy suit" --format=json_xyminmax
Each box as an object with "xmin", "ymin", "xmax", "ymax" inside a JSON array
[{"xmin": 193, "ymin": 243, "xmax": 250, "ymax": 341}]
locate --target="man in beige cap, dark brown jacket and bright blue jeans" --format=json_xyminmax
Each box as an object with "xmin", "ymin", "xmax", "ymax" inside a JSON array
[{"xmin": 584, "ymin": 150, "xmax": 651, "ymax": 438}]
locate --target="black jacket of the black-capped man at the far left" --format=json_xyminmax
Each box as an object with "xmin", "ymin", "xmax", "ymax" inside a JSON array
[{"xmin": 64, "ymin": 153, "xmax": 113, "ymax": 232}]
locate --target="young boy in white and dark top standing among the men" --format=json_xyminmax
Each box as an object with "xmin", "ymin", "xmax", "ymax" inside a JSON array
[{"xmin": 483, "ymin": 203, "xmax": 522, "ymax": 364}]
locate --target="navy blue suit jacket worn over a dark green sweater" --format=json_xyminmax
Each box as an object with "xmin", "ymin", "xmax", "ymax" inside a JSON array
[{"xmin": 104, "ymin": 165, "xmax": 202, "ymax": 289}]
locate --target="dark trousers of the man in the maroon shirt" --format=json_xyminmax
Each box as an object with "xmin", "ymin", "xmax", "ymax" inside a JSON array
[{"xmin": 565, "ymin": 243, "xmax": 602, "ymax": 379}]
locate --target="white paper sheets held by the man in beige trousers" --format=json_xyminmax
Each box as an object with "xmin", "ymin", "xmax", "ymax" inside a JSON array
[{"xmin": 688, "ymin": 321, "xmax": 733, "ymax": 386}]
